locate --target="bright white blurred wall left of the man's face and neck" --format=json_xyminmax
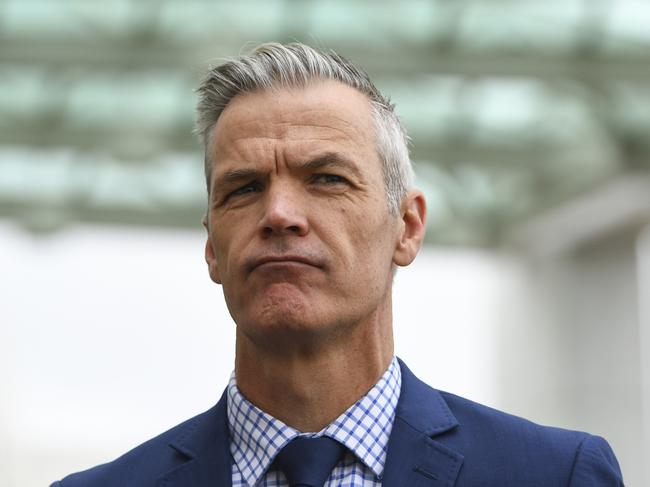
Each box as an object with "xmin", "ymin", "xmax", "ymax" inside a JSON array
[{"xmin": 0, "ymin": 226, "xmax": 234, "ymax": 487}]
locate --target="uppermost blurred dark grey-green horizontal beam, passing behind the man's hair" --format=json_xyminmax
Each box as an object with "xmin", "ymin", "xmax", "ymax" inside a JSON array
[{"xmin": 0, "ymin": 37, "xmax": 650, "ymax": 82}]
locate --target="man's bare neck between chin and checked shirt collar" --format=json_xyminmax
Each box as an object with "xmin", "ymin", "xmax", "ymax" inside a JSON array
[{"xmin": 235, "ymin": 305, "xmax": 393, "ymax": 432}]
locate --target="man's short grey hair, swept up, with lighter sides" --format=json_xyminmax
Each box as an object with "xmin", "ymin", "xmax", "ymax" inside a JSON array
[{"xmin": 195, "ymin": 43, "xmax": 414, "ymax": 215}]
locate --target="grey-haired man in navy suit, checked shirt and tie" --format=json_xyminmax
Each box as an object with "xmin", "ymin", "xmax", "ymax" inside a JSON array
[{"xmin": 54, "ymin": 44, "xmax": 622, "ymax": 487}]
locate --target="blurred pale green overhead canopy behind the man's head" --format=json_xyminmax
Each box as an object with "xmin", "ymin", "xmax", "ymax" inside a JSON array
[{"xmin": 0, "ymin": 0, "xmax": 650, "ymax": 245}]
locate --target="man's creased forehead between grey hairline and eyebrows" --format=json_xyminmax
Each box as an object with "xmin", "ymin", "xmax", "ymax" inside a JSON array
[{"xmin": 211, "ymin": 80, "xmax": 376, "ymax": 164}]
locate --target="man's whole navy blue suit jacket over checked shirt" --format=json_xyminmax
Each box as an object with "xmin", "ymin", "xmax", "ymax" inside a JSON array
[{"xmin": 51, "ymin": 362, "xmax": 623, "ymax": 487}]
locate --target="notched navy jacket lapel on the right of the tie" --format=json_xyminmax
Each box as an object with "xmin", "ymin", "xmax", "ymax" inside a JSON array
[{"xmin": 382, "ymin": 361, "xmax": 463, "ymax": 487}]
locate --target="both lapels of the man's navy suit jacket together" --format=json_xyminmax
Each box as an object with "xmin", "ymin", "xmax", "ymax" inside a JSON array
[{"xmin": 157, "ymin": 360, "xmax": 463, "ymax": 487}]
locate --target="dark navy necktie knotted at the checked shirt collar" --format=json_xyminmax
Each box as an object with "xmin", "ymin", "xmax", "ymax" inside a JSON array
[{"xmin": 275, "ymin": 436, "xmax": 345, "ymax": 487}]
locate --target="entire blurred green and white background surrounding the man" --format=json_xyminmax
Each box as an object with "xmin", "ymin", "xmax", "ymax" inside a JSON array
[{"xmin": 0, "ymin": 0, "xmax": 650, "ymax": 487}]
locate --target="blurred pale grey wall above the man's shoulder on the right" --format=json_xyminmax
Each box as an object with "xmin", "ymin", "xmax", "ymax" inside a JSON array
[{"xmin": 498, "ymin": 230, "xmax": 648, "ymax": 486}]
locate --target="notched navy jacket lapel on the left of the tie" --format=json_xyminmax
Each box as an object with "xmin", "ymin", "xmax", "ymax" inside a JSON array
[{"xmin": 156, "ymin": 392, "xmax": 232, "ymax": 487}]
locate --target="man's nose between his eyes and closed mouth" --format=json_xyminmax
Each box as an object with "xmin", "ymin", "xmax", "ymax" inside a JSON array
[{"xmin": 260, "ymin": 184, "xmax": 309, "ymax": 238}]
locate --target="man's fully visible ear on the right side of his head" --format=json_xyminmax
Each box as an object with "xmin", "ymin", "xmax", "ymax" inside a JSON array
[{"xmin": 393, "ymin": 190, "xmax": 427, "ymax": 266}]
